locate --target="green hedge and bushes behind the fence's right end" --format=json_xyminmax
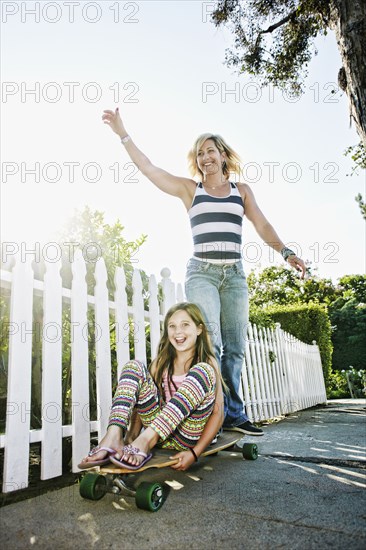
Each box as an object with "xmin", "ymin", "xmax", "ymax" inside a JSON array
[{"xmin": 248, "ymin": 266, "xmax": 366, "ymax": 395}]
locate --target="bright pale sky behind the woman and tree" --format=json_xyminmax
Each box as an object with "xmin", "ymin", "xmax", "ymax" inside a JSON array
[{"xmin": 0, "ymin": 0, "xmax": 365, "ymax": 283}]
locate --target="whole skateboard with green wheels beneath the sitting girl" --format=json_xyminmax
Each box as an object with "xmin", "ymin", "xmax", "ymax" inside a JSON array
[{"xmin": 79, "ymin": 431, "xmax": 258, "ymax": 512}]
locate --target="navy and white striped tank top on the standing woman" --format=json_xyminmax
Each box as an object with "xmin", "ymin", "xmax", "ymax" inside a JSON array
[{"xmin": 188, "ymin": 182, "xmax": 244, "ymax": 264}]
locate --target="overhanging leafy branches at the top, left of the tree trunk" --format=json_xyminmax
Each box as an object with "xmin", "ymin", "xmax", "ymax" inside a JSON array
[{"xmin": 212, "ymin": 0, "xmax": 330, "ymax": 95}]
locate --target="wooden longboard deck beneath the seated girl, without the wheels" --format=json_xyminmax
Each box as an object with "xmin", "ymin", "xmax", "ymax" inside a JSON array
[{"xmin": 98, "ymin": 431, "xmax": 244, "ymax": 474}]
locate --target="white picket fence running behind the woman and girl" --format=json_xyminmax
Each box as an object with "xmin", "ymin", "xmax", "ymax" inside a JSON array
[{"xmin": 0, "ymin": 251, "xmax": 326, "ymax": 493}]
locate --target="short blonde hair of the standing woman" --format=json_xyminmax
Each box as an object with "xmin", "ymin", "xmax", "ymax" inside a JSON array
[{"xmin": 188, "ymin": 133, "xmax": 241, "ymax": 177}]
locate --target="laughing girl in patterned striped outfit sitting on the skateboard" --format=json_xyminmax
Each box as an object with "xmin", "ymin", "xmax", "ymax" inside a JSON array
[{"xmin": 79, "ymin": 303, "xmax": 224, "ymax": 470}]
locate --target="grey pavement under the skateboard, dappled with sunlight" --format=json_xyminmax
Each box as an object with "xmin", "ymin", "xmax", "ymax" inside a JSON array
[{"xmin": 0, "ymin": 399, "xmax": 366, "ymax": 550}]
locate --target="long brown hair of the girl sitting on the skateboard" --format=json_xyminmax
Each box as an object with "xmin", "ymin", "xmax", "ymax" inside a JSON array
[{"xmin": 154, "ymin": 302, "xmax": 220, "ymax": 397}]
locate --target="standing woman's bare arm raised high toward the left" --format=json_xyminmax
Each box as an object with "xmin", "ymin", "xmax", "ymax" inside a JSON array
[{"xmin": 102, "ymin": 107, "xmax": 196, "ymax": 209}]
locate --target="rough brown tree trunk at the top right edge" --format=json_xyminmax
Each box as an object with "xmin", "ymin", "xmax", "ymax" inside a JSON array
[{"xmin": 330, "ymin": 0, "xmax": 366, "ymax": 147}]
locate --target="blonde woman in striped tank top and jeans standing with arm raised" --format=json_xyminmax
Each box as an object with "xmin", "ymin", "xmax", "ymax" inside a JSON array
[{"xmin": 102, "ymin": 108, "xmax": 306, "ymax": 435}]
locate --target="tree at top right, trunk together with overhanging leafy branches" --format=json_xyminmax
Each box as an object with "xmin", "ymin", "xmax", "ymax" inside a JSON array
[{"xmin": 212, "ymin": 0, "xmax": 366, "ymax": 146}]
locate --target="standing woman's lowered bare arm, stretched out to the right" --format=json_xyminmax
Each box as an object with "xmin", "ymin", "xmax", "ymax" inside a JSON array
[{"xmin": 239, "ymin": 183, "xmax": 306, "ymax": 279}]
